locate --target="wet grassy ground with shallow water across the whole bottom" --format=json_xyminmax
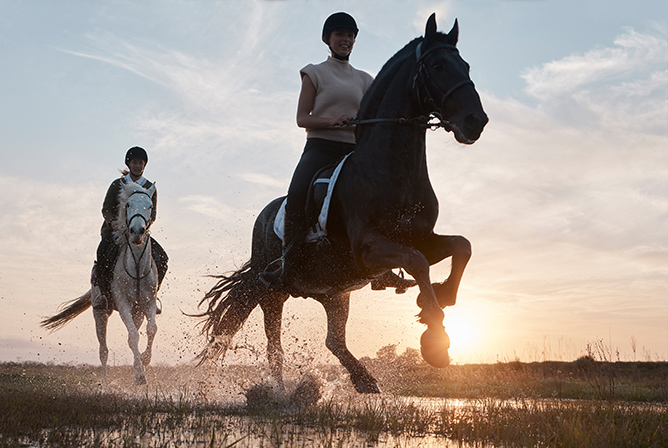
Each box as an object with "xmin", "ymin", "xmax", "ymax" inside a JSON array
[{"xmin": 0, "ymin": 360, "xmax": 668, "ymax": 447}]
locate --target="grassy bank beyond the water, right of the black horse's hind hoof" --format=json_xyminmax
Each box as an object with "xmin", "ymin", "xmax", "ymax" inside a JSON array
[{"xmin": 365, "ymin": 350, "xmax": 668, "ymax": 403}]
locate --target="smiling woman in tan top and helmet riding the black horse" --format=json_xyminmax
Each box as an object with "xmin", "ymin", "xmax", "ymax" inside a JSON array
[{"xmin": 260, "ymin": 12, "xmax": 414, "ymax": 289}]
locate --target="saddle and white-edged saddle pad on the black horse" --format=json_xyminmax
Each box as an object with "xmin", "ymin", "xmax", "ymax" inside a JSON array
[{"xmin": 274, "ymin": 153, "xmax": 352, "ymax": 243}]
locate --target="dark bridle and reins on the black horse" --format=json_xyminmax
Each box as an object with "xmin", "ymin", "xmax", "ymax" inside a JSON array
[{"xmin": 346, "ymin": 42, "xmax": 474, "ymax": 132}]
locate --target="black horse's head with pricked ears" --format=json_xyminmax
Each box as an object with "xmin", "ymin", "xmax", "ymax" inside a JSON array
[{"xmin": 414, "ymin": 14, "xmax": 489, "ymax": 144}]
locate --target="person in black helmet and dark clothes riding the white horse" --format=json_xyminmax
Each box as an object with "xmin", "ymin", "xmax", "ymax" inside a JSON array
[{"xmin": 93, "ymin": 146, "xmax": 168, "ymax": 310}]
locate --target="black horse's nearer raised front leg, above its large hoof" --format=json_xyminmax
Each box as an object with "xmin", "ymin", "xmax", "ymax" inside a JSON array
[{"xmin": 361, "ymin": 234, "xmax": 445, "ymax": 331}]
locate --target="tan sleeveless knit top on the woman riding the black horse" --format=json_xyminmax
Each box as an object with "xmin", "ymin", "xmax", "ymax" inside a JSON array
[{"xmin": 299, "ymin": 56, "xmax": 373, "ymax": 143}]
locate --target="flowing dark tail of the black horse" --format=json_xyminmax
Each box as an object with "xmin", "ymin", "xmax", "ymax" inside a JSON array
[{"xmin": 191, "ymin": 261, "xmax": 264, "ymax": 365}]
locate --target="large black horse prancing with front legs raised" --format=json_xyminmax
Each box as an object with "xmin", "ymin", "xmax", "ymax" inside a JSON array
[{"xmin": 197, "ymin": 14, "xmax": 488, "ymax": 393}]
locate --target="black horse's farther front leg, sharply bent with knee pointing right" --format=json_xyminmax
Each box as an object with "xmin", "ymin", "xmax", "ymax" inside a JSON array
[{"xmin": 418, "ymin": 233, "xmax": 471, "ymax": 308}]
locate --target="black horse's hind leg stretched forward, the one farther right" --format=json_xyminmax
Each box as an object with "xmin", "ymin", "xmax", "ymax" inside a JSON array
[{"xmin": 317, "ymin": 293, "xmax": 380, "ymax": 393}]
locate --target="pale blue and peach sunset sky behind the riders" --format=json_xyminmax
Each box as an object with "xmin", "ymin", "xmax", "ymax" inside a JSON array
[{"xmin": 0, "ymin": 0, "xmax": 668, "ymax": 368}]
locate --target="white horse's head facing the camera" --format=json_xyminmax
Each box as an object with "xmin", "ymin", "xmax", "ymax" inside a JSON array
[{"xmin": 121, "ymin": 184, "xmax": 155, "ymax": 246}]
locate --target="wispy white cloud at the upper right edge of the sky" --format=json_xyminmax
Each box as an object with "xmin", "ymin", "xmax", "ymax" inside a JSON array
[{"xmin": 522, "ymin": 28, "xmax": 668, "ymax": 134}]
